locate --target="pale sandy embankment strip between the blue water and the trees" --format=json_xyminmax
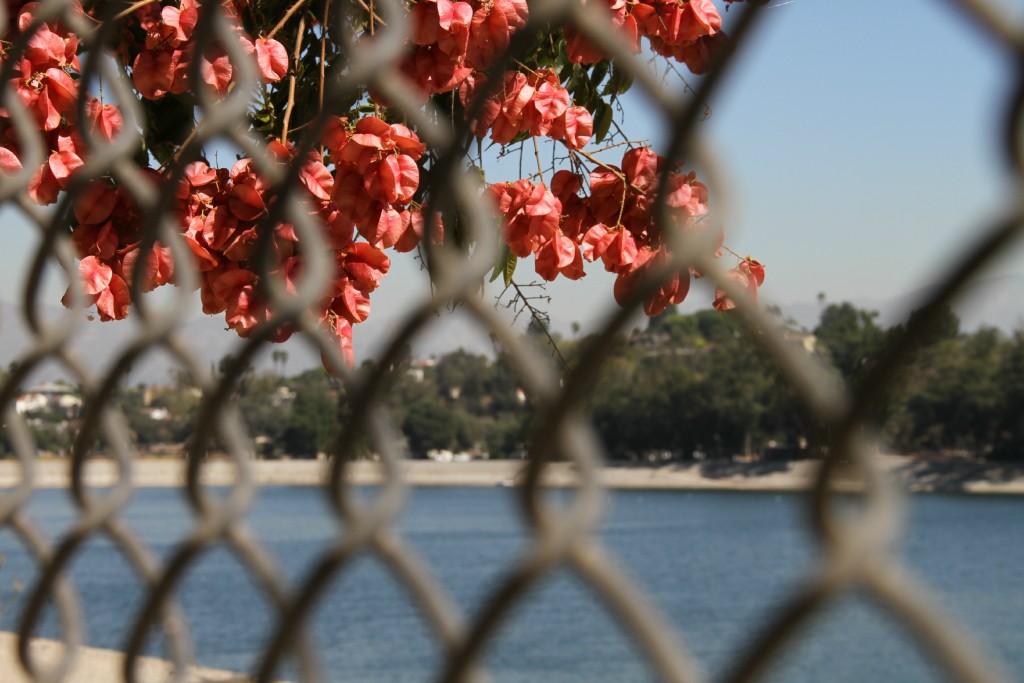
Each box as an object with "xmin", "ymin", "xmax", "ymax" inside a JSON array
[{"xmin": 0, "ymin": 456, "xmax": 1024, "ymax": 494}]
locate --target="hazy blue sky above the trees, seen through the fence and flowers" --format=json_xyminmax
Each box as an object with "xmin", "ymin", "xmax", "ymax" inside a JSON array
[{"xmin": 0, "ymin": 0, "xmax": 1024, "ymax": 358}]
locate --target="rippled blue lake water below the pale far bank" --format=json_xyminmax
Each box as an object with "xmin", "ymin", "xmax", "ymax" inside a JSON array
[{"xmin": 0, "ymin": 487, "xmax": 1024, "ymax": 683}]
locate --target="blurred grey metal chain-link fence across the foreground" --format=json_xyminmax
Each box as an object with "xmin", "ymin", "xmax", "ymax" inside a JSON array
[{"xmin": 0, "ymin": 0, "xmax": 1024, "ymax": 681}]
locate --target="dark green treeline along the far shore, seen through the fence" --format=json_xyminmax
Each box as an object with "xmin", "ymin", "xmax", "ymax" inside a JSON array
[{"xmin": 12, "ymin": 303, "xmax": 1024, "ymax": 461}]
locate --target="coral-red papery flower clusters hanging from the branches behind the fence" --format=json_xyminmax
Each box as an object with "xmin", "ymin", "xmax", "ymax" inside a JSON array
[{"xmin": 0, "ymin": 0, "xmax": 764, "ymax": 368}]
